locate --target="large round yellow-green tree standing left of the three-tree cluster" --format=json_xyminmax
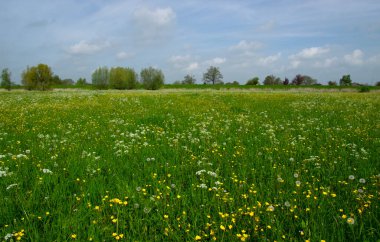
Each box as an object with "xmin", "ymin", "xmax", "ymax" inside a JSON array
[{"xmin": 21, "ymin": 64, "xmax": 53, "ymax": 91}]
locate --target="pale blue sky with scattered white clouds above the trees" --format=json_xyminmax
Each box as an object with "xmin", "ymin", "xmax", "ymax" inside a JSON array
[{"xmin": 0, "ymin": 0, "xmax": 380, "ymax": 84}]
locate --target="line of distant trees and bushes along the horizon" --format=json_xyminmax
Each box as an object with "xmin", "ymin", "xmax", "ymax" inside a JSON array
[{"xmin": 0, "ymin": 64, "xmax": 380, "ymax": 91}]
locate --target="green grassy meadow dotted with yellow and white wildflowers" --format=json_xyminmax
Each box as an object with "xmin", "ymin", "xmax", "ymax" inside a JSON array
[{"xmin": 0, "ymin": 90, "xmax": 380, "ymax": 241}]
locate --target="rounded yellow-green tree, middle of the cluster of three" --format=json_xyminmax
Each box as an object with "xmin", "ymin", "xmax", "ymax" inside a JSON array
[{"xmin": 109, "ymin": 67, "xmax": 137, "ymax": 89}]
